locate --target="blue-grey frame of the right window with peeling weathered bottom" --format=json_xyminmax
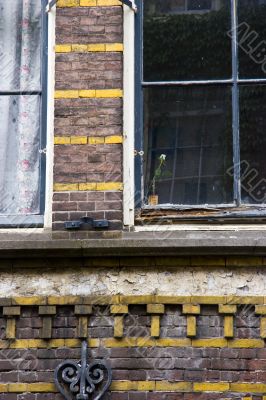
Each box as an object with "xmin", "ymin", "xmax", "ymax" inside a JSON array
[{"xmin": 135, "ymin": 0, "xmax": 266, "ymax": 223}]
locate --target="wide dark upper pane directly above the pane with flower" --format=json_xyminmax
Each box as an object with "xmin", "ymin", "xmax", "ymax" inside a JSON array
[{"xmin": 144, "ymin": 0, "xmax": 232, "ymax": 81}]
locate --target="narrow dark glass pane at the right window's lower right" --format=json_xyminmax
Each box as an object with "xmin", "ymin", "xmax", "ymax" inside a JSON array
[{"xmin": 240, "ymin": 86, "xmax": 266, "ymax": 204}]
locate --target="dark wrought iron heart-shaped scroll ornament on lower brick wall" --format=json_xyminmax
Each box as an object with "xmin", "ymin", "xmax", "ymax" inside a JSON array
[{"xmin": 54, "ymin": 340, "xmax": 112, "ymax": 400}]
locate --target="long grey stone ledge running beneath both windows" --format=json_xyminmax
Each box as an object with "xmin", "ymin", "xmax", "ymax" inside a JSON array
[{"xmin": 0, "ymin": 230, "xmax": 266, "ymax": 258}]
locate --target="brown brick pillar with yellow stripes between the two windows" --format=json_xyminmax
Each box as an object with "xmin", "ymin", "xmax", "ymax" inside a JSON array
[{"xmin": 53, "ymin": 0, "xmax": 123, "ymax": 230}]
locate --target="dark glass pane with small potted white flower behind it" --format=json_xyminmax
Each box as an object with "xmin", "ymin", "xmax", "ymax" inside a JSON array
[{"xmin": 144, "ymin": 86, "xmax": 233, "ymax": 205}]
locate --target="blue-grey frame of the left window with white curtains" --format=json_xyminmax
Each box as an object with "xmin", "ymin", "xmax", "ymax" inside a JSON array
[{"xmin": 0, "ymin": 0, "xmax": 48, "ymax": 228}]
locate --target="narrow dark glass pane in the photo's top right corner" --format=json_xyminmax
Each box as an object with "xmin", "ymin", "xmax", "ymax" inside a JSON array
[{"xmin": 237, "ymin": 0, "xmax": 266, "ymax": 78}]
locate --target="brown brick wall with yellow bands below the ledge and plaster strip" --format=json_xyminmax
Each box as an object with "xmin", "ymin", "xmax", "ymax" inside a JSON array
[{"xmin": 0, "ymin": 296, "xmax": 266, "ymax": 400}]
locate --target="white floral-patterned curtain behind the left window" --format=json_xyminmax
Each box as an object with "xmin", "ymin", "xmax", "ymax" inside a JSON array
[{"xmin": 0, "ymin": 0, "xmax": 42, "ymax": 215}]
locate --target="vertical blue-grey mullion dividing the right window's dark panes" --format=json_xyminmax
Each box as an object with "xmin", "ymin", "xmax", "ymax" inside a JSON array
[{"xmin": 231, "ymin": 0, "xmax": 241, "ymax": 205}]
